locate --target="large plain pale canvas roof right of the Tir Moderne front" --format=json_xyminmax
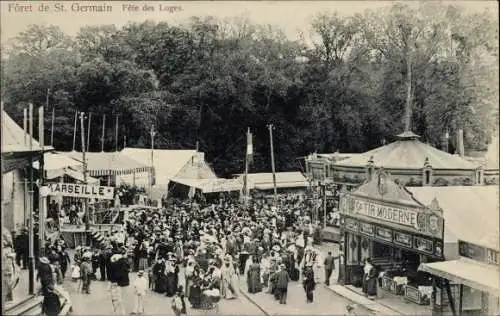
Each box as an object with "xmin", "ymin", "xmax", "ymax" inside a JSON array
[{"xmin": 407, "ymin": 186, "xmax": 500, "ymax": 249}]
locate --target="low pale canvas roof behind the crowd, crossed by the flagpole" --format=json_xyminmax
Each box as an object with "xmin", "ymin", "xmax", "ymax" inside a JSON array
[{"xmin": 238, "ymin": 171, "xmax": 308, "ymax": 190}]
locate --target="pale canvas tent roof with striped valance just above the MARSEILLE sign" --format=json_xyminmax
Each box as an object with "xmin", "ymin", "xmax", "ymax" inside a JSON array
[{"xmin": 66, "ymin": 151, "xmax": 150, "ymax": 177}]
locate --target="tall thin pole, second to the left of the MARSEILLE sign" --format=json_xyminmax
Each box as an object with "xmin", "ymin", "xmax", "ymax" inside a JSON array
[{"xmin": 28, "ymin": 103, "xmax": 35, "ymax": 295}]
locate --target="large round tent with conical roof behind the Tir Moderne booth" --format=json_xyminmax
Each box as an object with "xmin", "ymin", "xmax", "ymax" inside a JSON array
[{"xmin": 306, "ymin": 131, "xmax": 499, "ymax": 242}]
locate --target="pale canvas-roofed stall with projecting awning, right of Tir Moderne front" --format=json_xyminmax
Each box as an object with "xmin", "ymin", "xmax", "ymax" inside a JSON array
[{"xmin": 410, "ymin": 186, "xmax": 500, "ymax": 315}]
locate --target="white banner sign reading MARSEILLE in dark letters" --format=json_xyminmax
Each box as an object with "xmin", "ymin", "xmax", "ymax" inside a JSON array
[{"xmin": 48, "ymin": 183, "xmax": 115, "ymax": 200}]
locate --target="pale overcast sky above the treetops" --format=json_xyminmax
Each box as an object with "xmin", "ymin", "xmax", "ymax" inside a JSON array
[{"xmin": 1, "ymin": 0, "xmax": 498, "ymax": 43}]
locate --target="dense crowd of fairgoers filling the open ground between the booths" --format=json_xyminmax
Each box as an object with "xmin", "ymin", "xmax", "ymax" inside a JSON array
[{"xmin": 2, "ymin": 195, "xmax": 348, "ymax": 315}]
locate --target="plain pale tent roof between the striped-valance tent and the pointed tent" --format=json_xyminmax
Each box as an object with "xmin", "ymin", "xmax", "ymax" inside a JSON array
[{"xmin": 121, "ymin": 147, "xmax": 196, "ymax": 184}]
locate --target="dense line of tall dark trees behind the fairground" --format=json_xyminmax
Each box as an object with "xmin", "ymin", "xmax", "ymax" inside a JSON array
[{"xmin": 2, "ymin": 2, "xmax": 498, "ymax": 175}]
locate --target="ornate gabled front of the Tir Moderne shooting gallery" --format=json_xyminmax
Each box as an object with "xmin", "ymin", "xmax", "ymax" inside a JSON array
[{"xmin": 340, "ymin": 169, "xmax": 444, "ymax": 305}]
